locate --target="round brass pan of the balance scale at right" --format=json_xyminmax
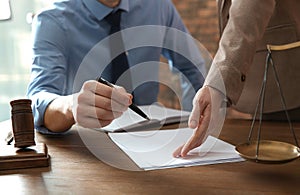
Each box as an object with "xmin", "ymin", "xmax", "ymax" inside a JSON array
[{"xmin": 235, "ymin": 140, "xmax": 300, "ymax": 164}]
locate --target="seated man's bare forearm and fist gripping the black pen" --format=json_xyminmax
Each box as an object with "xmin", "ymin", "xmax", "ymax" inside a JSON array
[{"xmin": 44, "ymin": 80, "xmax": 132, "ymax": 132}]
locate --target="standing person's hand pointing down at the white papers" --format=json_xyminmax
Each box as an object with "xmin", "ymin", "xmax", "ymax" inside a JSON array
[{"xmin": 173, "ymin": 86, "xmax": 225, "ymax": 157}]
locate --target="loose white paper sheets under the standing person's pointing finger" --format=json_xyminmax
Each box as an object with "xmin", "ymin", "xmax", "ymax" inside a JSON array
[{"xmin": 109, "ymin": 128, "xmax": 244, "ymax": 170}]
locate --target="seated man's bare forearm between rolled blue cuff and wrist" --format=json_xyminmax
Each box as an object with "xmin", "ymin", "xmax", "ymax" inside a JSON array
[{"xmin": 44, "ymin": 95, "xmax": 75, "ymax": 132}]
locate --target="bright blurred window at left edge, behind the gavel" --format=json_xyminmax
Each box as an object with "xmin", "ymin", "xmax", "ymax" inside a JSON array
[{"xmin": 0, "ymin": 0, "xmax": 50, "ymax": 121}]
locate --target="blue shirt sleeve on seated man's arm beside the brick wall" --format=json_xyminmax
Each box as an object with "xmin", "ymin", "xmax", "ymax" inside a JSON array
[{"xmin": 162, "ymin": 1, "xmax": 206, "ymax": 110}]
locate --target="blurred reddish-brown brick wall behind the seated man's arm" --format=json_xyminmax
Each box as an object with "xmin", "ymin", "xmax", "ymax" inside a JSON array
[{"xmin": 158, "ymin": 0, "xmax": 219, "ymax": 109}]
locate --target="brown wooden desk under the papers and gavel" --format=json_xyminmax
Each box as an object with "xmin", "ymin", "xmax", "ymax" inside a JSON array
[{"xmin": 0, "ymin": 120, "xmax": 300, "ymax": 194}]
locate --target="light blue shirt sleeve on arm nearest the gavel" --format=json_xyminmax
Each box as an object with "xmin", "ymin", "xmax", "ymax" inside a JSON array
[{"xmin": 27, "ymin": 12, "xmax": 66, "ymax": 132}]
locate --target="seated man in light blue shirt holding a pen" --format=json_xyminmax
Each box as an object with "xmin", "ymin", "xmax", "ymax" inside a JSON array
[{"xmin": 27, "ymin": 0, "xmax": 206, "ymax": 133}]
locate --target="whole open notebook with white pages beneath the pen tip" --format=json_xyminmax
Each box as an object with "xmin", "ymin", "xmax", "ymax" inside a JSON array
[{"xmin": 96, "ymin": 105, "xmax": 190, "ymax": 132}]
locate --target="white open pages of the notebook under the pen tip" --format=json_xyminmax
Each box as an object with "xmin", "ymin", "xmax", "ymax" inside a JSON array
[{"xmin": 97, "ymin": 105, "xmax": 190, "ymax": 132}]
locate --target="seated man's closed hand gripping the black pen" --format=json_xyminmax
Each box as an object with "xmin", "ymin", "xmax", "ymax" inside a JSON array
[{"xmin": 73, "ymin": 81, "xmax": 132, "ymax": 128}]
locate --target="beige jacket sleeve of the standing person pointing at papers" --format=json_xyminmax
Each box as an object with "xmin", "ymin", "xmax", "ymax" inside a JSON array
[{"xmin": 204, "ymin": 0, "xmax": 275, "ymax": 104}]
